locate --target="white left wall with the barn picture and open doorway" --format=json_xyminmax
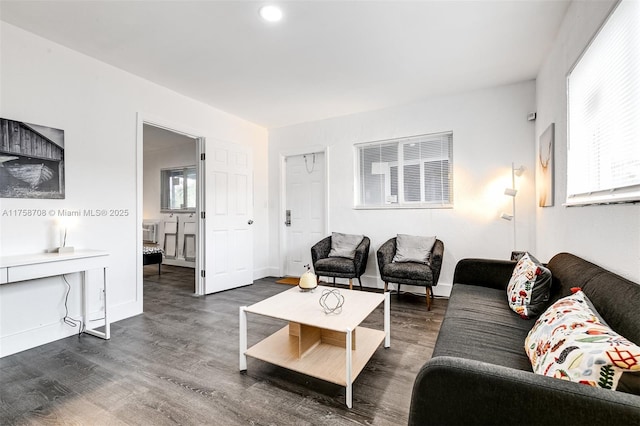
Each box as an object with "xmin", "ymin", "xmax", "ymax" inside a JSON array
[{"xmin": 0, "ymin": 22, "xmax": 268, "ymax": 355}]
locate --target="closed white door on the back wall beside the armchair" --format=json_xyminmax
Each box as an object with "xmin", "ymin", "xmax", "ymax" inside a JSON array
[{"xmin": 284, "ymin": 152, "xmax": 326, "ymax": 277}]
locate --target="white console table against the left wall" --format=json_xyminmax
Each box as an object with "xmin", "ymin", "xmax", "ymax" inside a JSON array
[{"xmin": 0, "ymin": 250, "xmax": 111, "ymax": 339}]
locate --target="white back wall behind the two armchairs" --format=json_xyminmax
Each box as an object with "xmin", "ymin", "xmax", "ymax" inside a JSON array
[{"xmin": 269, "ymin": 82, "xmax": 535, "ymax": 294}]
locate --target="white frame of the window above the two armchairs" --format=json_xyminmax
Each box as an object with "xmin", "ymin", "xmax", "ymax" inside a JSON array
[{"xmin": 354, "ymin": 131, "xmax": 454, "ymax": 210}]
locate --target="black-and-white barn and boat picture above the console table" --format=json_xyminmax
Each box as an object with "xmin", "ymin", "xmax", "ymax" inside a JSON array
[{"xmin": 0, "ymin": 118, "xmax": 64, "ymax": 199}]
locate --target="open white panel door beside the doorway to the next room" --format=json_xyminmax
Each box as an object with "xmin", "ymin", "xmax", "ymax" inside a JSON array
[{"xmin": 204, "ymin": 142, "xmax": 253, "ymax": 294}]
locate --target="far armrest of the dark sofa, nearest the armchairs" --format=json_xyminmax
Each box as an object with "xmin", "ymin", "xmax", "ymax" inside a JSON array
[{"xmin": 453, "ymin": 259, "xmax": 516, "ymax": 290}]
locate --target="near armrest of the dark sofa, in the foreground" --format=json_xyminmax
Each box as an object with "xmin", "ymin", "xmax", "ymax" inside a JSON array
[{"xmin": 409, "ymin": 356, "xmax": 640, "ymax": 426}]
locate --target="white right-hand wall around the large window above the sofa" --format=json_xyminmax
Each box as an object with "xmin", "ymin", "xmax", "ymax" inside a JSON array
[{"xmin": 536, "ymin": 1, "xmax": 640, "ymax": 282}]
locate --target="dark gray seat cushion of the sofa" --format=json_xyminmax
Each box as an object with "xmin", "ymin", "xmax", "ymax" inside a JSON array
[{"xmin": 433, "ymin": 284, "xmax": 533, "ymax": 372}]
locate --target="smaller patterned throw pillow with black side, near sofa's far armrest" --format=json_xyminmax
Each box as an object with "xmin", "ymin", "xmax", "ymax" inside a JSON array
[{"xmin": 507, "ymin": 253, "xmax": 551, "ymax": 319}]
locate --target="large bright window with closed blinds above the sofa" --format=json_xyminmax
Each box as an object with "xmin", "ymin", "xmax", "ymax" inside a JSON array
[{"xmin": 567, "ymin": 0, "xmax": 640, "ymax": 205}]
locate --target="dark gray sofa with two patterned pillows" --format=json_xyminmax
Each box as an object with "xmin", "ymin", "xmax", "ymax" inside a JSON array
[{"xmin": 409, "ymin": 253, "xmax": 640, "ymax": 426}]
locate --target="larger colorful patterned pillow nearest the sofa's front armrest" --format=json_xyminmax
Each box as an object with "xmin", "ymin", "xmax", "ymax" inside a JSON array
[{"xmin": 525, "ymin": 291, "xmax": 640, "ymax": 393}]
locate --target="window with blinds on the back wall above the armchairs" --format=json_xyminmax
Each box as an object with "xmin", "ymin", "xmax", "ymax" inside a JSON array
[{"xmin": 355, "ymin": 132, "xmax": 453, "ymax": 208}]
